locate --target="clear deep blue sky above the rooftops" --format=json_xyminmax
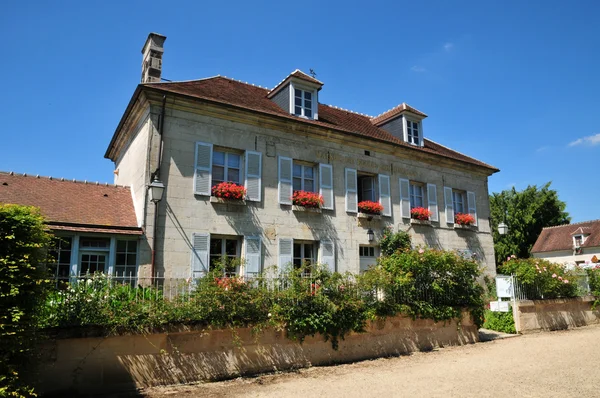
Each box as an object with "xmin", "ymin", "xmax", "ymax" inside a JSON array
[{"xmin": 0, "ymin": 0, "xmax": 600, "ymax": 221}]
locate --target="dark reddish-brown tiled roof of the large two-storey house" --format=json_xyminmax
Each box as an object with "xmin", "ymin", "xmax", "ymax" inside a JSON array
[{"xmin": 141, "ymin": 76, "xmax": 498, "ymax": 172}]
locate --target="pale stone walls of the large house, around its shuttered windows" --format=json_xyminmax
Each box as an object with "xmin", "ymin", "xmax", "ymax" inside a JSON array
[{"xmin": 113, "ymin": 93, "xmax": 495, "ymax": 278}]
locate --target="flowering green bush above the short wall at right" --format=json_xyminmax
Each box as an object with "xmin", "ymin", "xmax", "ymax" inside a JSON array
[{"xmin": 499, "ymin": 256, "xmax": 577, "ymax": 300}]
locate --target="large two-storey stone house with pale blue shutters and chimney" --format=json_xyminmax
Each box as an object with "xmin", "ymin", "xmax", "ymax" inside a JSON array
[{"xmin": 105, "ymin": 34, "xmax": 498, "ymax": 278}]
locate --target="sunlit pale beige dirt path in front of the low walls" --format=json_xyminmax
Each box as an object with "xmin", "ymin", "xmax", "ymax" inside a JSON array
[{"xmin": 139, "ymin": 325, "xmax": 600, "ymax": 398}]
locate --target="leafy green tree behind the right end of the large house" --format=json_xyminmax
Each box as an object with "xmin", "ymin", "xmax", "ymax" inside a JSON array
[{"xmin": 490, "ymin": 182, "xmax": 571, "ymax": 266}]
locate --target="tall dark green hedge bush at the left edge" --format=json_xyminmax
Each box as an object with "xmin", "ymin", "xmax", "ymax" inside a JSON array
[{"xmin": 0, "ymin": 204, "xmax": 50, "ymax": 397}]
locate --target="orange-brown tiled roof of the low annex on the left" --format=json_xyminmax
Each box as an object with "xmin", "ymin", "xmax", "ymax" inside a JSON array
[{"xmin": 0, "ymin": 172, "xmax": 141, "ymax": 234}]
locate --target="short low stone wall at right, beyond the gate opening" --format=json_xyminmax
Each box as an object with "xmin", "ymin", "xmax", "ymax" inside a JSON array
[{"xmin": 513, "ymin": 296, "xmax": 600, "ymax": 333}]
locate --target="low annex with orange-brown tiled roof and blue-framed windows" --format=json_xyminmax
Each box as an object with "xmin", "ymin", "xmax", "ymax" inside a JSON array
[{"xmin": 0, "ymin": 172, "xmax": 145, "ymax": 279}]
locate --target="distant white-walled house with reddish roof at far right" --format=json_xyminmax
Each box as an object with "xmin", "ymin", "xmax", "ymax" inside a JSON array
[{"xmin": 531, "ymin": 220, "xmax": 600, "ymax": 265}]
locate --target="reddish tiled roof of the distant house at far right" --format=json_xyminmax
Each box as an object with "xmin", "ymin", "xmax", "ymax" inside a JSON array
[{"xmin": 531, "ymin": 220, "xmax": 600, "ymax": 253}]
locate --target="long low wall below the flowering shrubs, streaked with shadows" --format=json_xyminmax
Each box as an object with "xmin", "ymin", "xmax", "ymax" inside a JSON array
[{"xmin": 37, "ymin": 313, "xmax": 478, "ymax": 394}]
